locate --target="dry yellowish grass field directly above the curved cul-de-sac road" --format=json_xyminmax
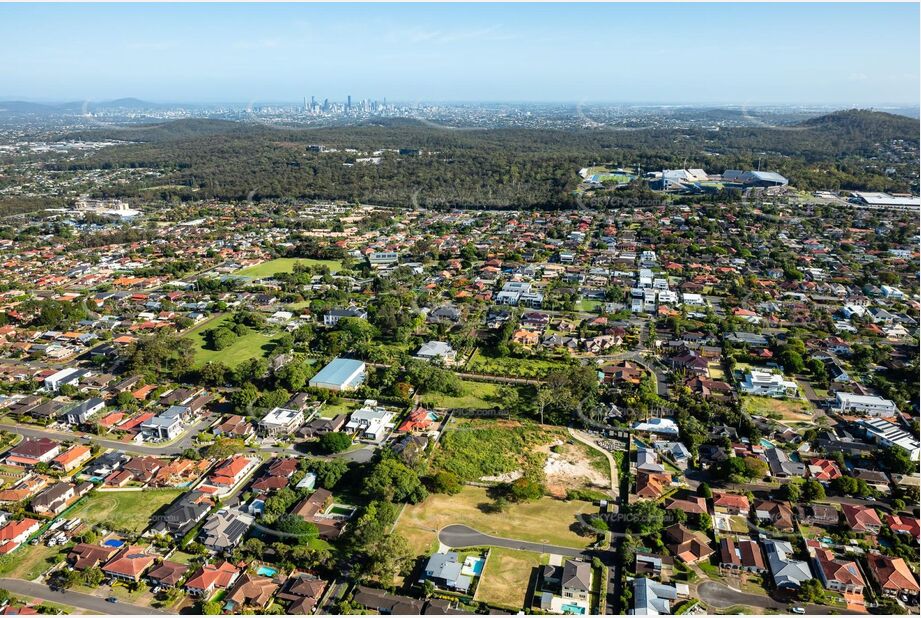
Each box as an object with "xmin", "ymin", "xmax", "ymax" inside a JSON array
[{"xmin": 397, "ymin": 486, "xmax": 596, "ymax": 555}]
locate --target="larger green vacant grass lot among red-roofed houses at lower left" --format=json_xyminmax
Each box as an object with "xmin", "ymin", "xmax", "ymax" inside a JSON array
[{"xmin": 67, "ymin": 489, "xmax": 183, "ymax": 533}]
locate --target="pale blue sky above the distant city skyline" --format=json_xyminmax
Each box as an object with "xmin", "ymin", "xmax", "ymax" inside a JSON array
[{"xmin": 0, "ymin": 3, "xmax": 921, "ymax": 106}]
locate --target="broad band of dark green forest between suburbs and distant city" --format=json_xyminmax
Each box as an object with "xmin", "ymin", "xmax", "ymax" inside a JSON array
[{"xmin": 55, "ymin": 110, "xmax": 918, "ymax": 208}]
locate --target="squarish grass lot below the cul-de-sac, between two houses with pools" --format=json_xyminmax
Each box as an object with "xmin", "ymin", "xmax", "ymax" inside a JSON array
[{"xmin": 474, "ymin": 547, "xmax": 550, "ymax": 610}]
